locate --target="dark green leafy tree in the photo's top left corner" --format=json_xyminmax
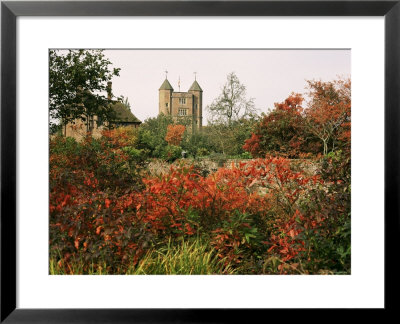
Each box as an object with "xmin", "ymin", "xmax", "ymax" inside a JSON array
[{"xmin": 49, "ymin": 49, "xmax": 120, "ymax": 132}]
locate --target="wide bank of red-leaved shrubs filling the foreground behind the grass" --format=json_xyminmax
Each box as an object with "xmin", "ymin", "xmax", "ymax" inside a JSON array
[{"xmin": 50, "ymin": 131, "xmax": 348, "ymax": 274}]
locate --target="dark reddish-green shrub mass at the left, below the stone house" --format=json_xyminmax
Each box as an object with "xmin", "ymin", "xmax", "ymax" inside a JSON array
[{"xmin": 50, "ymin": 130, "xmax": 145, "ymax": 270}]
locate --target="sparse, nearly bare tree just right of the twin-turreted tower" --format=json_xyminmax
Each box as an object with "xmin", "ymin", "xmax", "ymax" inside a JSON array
[{"xmin": 207, "ymin": 72, "xmax": 256, "ymax": 126}]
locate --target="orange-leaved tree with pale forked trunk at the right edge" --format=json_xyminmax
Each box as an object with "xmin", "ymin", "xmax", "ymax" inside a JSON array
[{"xmin": 305, "ymin": 79, "xmax": 351, "ymax": 155}]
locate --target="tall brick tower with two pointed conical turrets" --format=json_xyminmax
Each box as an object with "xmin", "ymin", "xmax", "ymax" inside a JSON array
[{"xmin": 158, "ymin": 78, "xmax": 203, "ymax": 130}]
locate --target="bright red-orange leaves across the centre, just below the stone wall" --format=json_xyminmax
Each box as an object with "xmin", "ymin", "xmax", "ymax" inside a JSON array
[{"xmin": 136, "ymin": 158, "xmax": 317, "ymax": 240}]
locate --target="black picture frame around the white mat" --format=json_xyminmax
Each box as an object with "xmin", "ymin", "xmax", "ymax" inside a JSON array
[{"xmin": 0, "ymin": 0, "xmax": 400, "ymax": 323}]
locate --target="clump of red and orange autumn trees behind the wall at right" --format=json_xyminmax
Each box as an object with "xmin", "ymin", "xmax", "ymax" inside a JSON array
[{"xmin": 243, "ymin": 79, "xmax": 351, "ymax": 158}]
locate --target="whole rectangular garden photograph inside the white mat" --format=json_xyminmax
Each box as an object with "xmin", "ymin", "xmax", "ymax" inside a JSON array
[{"xmin": 49, "ymin": 48, "xmax": 351, "ymax": 275}]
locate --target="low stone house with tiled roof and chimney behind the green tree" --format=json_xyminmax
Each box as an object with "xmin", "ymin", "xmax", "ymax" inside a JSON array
[{"xmin": 63, "ymin": 82, "xmax": 142, "ymax": 141}]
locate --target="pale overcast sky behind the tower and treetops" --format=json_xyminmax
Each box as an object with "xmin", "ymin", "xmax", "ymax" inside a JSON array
[{"xmin": 105, "ymin": 50, "xmax": 351, "ymax": 123}]
